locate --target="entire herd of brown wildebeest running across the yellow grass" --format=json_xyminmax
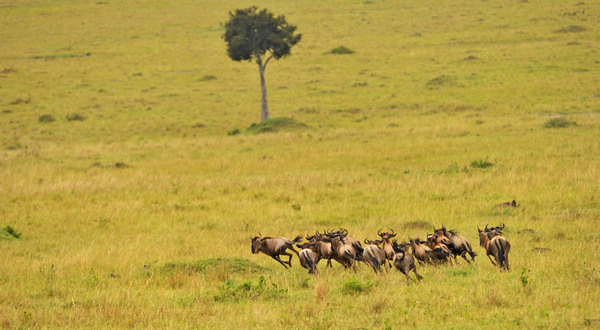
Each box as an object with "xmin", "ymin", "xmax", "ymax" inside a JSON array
[{"xmin": 250, "ymin": 224, "xmax": 510, "ymax": 284}]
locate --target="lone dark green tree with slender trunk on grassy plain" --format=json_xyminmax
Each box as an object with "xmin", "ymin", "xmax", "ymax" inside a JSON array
[{"xmin": 223, "ymin": 6, "xmax": 302, "ymax": 121}]
